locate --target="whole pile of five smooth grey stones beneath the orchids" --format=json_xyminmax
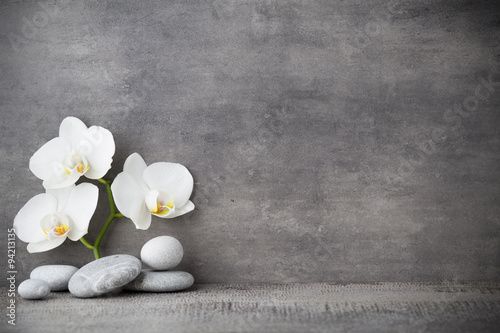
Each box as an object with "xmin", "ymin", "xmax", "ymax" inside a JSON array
[{"xmin": 18, "ymin": 236, "xmax": 194, "ymax": 299}]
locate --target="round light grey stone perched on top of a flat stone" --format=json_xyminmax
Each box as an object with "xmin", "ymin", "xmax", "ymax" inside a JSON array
[{"xmin": 141, "ymin": 236, "xmax": 184, "ymax": 271}]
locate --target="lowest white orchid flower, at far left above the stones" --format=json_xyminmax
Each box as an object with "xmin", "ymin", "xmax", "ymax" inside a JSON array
[{"xmin": 14, "ymin": 183, "xmax": 99, "ymax": 253}]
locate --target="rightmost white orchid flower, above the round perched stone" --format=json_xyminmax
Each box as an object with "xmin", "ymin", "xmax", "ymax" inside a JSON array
[{"xmin": 111, "ymin": 153, "xmax": 194, "ymax": 230}]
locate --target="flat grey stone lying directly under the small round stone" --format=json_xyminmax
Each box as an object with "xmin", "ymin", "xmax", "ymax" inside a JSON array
[{"xmin": 124, "ymin": 270, "xmax": 194, "ymax": 292}]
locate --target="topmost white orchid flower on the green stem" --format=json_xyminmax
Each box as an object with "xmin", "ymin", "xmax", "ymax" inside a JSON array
[{"xmin": 29, "ymin": 117, "xmax": 115, "ymax": 189}]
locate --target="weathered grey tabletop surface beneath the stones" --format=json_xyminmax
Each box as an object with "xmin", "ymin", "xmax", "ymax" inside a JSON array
[{"xmin": 2, "ymin": 283, "xmax": 500, "ymax": 332}]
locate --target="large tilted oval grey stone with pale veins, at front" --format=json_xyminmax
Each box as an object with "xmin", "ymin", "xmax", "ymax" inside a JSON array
[{"xmin": 68, "ymin": 254, "xmax": 141, "ymax": 298}]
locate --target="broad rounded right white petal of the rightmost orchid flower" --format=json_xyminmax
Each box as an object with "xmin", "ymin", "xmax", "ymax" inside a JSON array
[{"xmin": 143, "ymin": 162, "xmax": 193, "ymax": 207}]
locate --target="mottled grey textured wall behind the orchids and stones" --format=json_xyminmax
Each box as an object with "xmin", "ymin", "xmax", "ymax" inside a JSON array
[{"xmin": 0, "ymin": 0, "xmax": 500, "ymax": 284}]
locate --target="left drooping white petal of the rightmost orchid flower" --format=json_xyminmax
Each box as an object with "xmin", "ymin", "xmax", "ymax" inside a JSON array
[{"xmin": 111, "ymin": 172, "xmax": 151, "ymax": 230}]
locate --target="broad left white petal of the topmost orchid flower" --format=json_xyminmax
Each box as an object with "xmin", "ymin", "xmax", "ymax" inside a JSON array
[{"xmin": 29, "ymin": 138, "xmax": 71, "ymax": 180}]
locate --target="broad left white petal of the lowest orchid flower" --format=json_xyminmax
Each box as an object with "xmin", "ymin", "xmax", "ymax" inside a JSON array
[{"xmin": 14, "ymin": 193, "xmax": 57, "ymax": 243}]
